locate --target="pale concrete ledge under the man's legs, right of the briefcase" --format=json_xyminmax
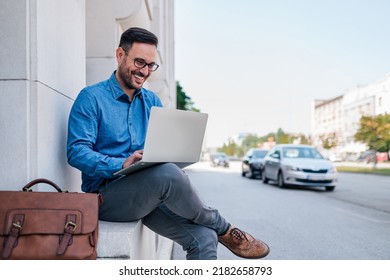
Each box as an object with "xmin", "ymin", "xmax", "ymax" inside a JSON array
[{"xmin": 97, "ymin": 220, "xmax": 173, "ymax": 260}]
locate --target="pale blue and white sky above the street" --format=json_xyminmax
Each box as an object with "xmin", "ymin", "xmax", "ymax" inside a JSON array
[{"xmin": 175, "ymin": 0, "xmax": 390, "ymax": 147}]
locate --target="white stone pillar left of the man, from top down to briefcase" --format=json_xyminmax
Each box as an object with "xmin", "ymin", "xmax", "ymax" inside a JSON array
[{"xmin": 0, "ymin": 0, "xmax": 85, "ymax": 191}]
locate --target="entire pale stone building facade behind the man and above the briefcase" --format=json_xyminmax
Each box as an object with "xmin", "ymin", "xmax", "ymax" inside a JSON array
[{"xmin": 0, "ymin": 0, "xmax": 176, "ymax": 191}]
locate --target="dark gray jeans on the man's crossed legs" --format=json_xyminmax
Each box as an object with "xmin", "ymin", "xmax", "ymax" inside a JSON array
[{"xmin": 99, "ymin": 163, "xmax": 230, "ymax": 259}]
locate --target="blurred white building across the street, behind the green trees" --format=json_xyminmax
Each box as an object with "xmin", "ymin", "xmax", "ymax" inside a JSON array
[{"xmin": 312, "ymin": 74, "xmax": 390, "ymax": 159}]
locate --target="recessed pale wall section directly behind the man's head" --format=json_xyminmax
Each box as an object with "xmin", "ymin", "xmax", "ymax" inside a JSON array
[{"xmin": 86, "ymin": 0, "xmax": 176, "ymax": 108}]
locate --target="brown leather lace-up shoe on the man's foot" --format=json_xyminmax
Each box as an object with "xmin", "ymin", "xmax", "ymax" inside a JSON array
[{"xmin": 218, "ymin": 226, "xmax": 270, "ymax": 259}]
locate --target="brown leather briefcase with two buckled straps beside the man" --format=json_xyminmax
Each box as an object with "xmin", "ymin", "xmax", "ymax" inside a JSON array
[{"xmin": 0, "ymin": 179, "xmax": 99, "ymax": 260}]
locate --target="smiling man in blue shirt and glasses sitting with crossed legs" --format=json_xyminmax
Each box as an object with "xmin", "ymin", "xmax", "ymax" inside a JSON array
[{"xmin": 67, "ymin": 28, "xmax": 269, "ymax": 260}]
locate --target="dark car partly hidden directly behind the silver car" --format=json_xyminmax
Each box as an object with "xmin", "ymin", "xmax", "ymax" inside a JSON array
[{"xmin": 241, "ymin": 148, "xmax": 268, "ymax": 179}]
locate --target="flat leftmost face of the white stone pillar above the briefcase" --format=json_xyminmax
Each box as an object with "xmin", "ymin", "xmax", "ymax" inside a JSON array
[{"xmin": 0, "ymin": 0, "xmax": 30, "ymax": 189}]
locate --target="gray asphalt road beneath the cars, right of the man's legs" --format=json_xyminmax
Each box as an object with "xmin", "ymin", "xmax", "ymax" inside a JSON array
[{"xmin": 173, "ymin": 162, "xmax": 390, "ymax": 260}]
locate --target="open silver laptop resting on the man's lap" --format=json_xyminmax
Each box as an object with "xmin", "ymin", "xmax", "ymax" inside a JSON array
[{"xmin": 114, "ymin": 107, "xmax": 208, "ymax": 175}]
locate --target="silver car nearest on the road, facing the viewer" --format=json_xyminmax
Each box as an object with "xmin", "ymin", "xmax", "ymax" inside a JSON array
[{"xmin": 263, "ymin": 144, "xmax": 338, "ymax": 191}]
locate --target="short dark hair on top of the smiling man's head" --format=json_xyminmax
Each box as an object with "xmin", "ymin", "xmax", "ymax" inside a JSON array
[{"xmin": 119, "ymin": 27, "xmax": 158, "ymax": 52}]
